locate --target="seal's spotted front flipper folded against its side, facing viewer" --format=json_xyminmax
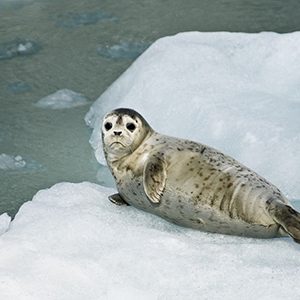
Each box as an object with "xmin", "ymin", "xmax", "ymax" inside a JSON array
[{"xmin": 143, "ymin": 156, "xmax": 167, "ymax": 203}]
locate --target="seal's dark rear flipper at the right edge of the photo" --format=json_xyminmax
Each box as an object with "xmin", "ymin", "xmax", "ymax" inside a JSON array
[{"xmin": 266, "ymin": 199, "xmax": 300, "ymax": 243}]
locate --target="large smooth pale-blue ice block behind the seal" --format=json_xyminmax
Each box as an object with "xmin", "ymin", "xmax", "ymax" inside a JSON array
[{"xmin": 86, "ymin": 32, "xmax": 300, "ymax": 198}]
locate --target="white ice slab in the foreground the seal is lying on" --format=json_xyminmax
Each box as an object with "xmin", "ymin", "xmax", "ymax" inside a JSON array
[{"xmin": 0, "ymin": 183, "xmax": 300, "ymax": 300}]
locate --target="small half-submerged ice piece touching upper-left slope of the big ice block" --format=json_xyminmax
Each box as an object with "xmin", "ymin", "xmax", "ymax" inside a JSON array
[{"xmin": 97, "ymin": 41, "xmax": 149, "ymax": 59}]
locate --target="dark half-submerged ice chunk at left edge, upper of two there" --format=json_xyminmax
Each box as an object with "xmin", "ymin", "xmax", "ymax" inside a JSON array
[{"xmin": 0, "ymin": 39, "xmax": 40, "ymax": 60}]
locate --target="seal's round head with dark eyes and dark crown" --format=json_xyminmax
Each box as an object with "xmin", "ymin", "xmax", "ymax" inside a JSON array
[{"xmin": 102, "ymin": 108, "xmax": 153, "ymax": 161}]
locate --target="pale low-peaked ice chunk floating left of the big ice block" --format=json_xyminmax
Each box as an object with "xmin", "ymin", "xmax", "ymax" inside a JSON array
[{"xmin": 35, "ymin": 89, "xmax": 89, "ymax": 109}]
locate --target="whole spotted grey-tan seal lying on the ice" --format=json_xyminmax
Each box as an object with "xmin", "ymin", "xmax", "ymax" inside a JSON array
[{"xmin": 102, "ymin": 108, "xmax": 300, "ymax": 243}]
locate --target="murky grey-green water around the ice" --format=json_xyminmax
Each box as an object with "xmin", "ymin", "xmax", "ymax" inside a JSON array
[{"xmin": 0, "ymin": 0, "xmax": 300, "ymax": 215}]
